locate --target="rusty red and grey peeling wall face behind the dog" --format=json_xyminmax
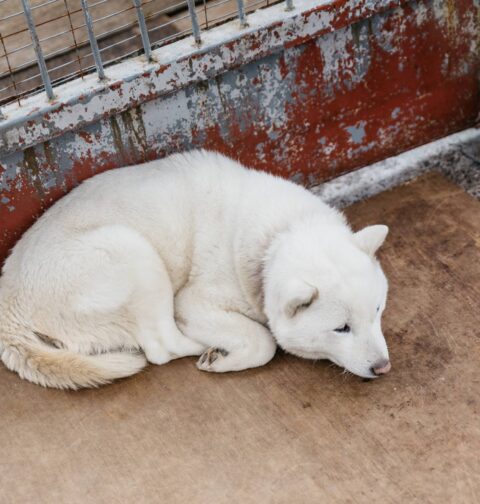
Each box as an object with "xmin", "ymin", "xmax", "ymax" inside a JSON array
[{"xmin": 0, "ymin": 0, "xmax": 480, "ymax": 266}]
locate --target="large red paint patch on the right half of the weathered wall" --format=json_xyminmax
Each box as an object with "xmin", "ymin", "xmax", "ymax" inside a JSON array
[{"xmin": 181, "ymin": 2, "xmax": 480, "ymax": 182}]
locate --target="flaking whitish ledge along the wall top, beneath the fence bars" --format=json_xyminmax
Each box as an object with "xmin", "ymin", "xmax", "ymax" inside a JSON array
[{"xmin": 0, "ymin": 0, "xmax": 405, "ymax": 158}]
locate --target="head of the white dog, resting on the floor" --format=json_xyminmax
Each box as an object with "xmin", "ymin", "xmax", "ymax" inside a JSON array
[{"xmin": 264, "ymin": 223, "xmax": 390, "ymax": 378}]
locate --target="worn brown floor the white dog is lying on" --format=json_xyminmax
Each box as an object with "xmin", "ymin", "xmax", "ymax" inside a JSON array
[{"xmin": 0, "ymin": 174, "xmax": 480, "ymax": 504}]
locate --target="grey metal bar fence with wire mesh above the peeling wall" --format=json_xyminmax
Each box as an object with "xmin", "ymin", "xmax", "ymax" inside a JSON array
[{"xmin": 0, "ymin": 0, "xmax": 284, "ymax": 113}]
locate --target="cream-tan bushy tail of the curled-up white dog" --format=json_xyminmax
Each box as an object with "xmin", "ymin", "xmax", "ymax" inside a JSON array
[{"xmin": 0, "ymin": 333, "xmax": 147, "ymax": 389}]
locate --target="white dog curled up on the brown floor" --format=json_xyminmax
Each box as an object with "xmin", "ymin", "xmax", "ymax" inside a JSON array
[{"xmin": 0, "ymin": 151, "xmax": 390, "ymax": 388}]
